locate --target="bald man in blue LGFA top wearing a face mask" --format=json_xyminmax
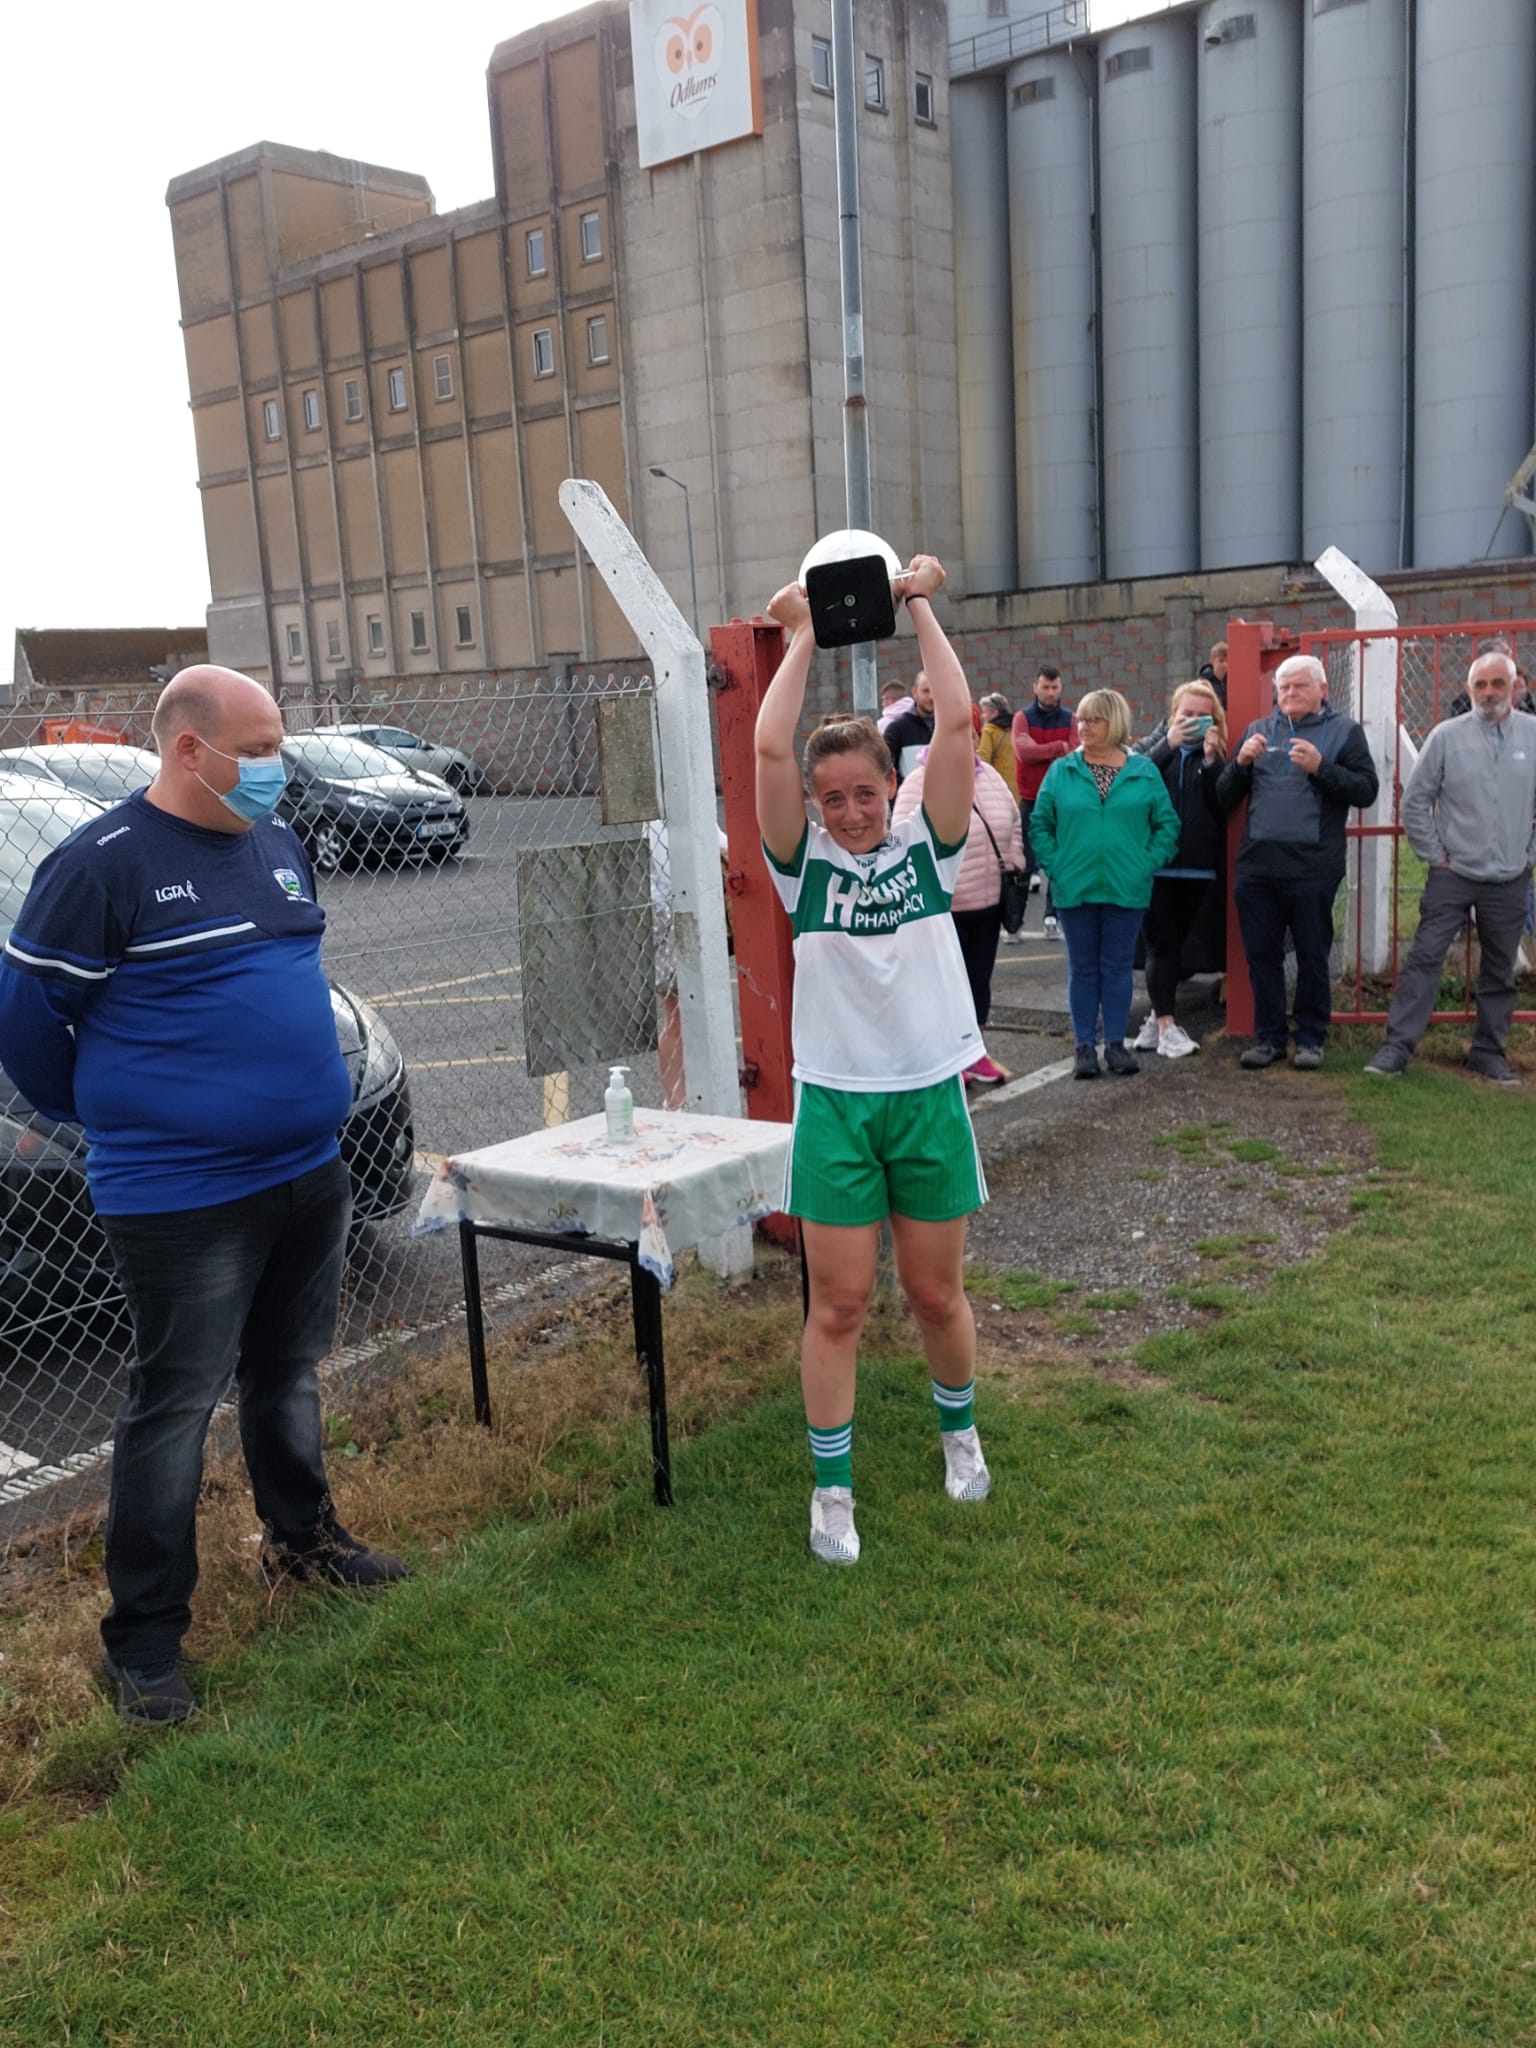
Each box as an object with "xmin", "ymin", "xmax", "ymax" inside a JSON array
[{"xmin": 0, "ymin": 668, "xmax": 406, "ymax": 1724}]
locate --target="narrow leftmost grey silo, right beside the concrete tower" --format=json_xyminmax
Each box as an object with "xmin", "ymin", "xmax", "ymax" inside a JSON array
[{"xmin": 950, "ymin": 76, "xmax": 1018, "ymax": 590}]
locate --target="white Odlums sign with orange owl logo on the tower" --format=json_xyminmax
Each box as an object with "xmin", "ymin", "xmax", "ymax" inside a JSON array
[{"xmin": 629, "ymin": 0, "xmax": 762, "ymax": 168}]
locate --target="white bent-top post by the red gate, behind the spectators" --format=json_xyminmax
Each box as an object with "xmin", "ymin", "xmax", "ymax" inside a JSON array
[{"xmin": 1313, "ymin": 547, "xmax": 1419, "ymax": 975}]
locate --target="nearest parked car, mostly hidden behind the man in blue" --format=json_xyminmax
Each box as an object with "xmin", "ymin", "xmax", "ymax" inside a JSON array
[{"xmin": 0, "ymin": 774, "xmax": 416, "ymax": 1348}]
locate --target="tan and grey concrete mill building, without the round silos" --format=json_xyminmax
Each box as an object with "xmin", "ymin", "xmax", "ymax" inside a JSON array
[{"xmin": 168, "ymin": 0, "xmax": 961, "ymax": 702}]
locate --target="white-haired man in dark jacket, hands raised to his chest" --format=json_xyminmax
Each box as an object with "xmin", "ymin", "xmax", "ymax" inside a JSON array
[{"xmin": 1217, "ymin": 653, "xmax": 1378, "ymax": 1069}]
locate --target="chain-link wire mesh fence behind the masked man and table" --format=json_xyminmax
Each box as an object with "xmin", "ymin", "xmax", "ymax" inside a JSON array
[{"xmin": 0, "ymin": 672, "xmax": 680, "ymax": 1554}]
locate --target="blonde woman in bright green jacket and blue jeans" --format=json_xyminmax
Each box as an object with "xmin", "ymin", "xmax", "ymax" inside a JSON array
[{"xmin": 1030, "ymin": 690, "xmax": 1180, "ymax": 1081}]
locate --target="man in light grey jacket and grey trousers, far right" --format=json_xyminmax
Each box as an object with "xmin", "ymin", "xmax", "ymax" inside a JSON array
[{"xmin": 1366, "ymin": 653, "xmax": 1536, "ymax": 1087}]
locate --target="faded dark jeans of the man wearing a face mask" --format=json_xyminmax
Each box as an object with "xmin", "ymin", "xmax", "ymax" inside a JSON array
[{"xmin": 100, "ymin": 1159, "xmax": 352, "ymax": 1671}]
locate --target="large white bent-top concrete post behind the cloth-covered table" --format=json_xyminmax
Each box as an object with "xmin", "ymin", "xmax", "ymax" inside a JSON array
[{"xmin": 559, "ymin": 477, "xmax": 752, "ymax": 1274}]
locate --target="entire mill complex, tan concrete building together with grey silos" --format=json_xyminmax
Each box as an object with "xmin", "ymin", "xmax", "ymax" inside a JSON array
[{"xmin": 168, "ymin": 0, "xmax": 1536, "ymax": 700}]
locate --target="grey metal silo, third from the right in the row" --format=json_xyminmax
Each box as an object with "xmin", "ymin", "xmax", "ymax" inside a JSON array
[{"xmin": 1196, "ymin": 0, "xmax": 1300, "ymax": 569}]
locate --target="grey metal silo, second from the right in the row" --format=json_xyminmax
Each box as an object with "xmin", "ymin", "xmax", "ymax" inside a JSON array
[{"xmin": 1300, "ymin": 0, "xmax": 1413, "ymax": 575}]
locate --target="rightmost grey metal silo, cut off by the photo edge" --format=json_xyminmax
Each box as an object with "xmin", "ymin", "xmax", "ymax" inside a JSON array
[{"xmin": 1413, "ymin": 0, "xmax": 1536, "ymax": 567}]
